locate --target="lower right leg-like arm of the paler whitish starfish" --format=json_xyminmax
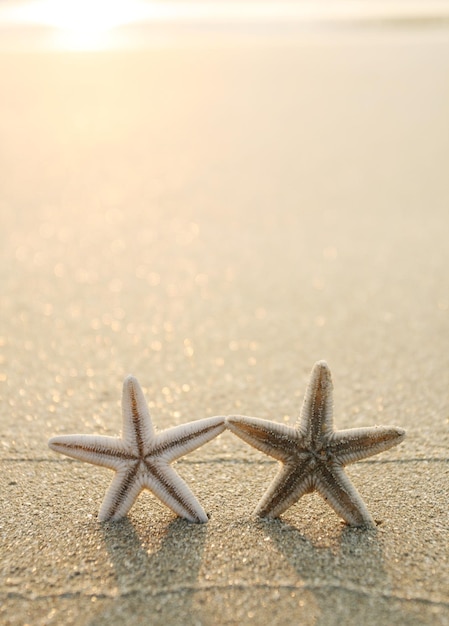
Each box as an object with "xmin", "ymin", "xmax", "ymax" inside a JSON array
[{"xmin": 145, "ymin": 458, "xmax": 208, "ymax": 523}]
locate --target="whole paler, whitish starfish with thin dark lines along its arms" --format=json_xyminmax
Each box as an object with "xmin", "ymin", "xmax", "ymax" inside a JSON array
[{"xmin": 48, "ymin": 376, "xmax": 225, "ymax": 522}]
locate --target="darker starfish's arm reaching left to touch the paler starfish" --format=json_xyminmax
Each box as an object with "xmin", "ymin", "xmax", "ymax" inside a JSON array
[{"xmin": 226, "ymin": 415, "xmax": 301, "ymax": 461}]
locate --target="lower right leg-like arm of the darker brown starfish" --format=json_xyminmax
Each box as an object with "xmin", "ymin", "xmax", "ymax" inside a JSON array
[{"xmin": 314, "ymin": 464, "xmax": 375, "ymax": 527}]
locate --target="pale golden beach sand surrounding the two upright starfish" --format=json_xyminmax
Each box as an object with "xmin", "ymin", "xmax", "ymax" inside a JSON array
[{"xmin": 0, "ymin": 25, "xmax": 449, "ymax": 626}]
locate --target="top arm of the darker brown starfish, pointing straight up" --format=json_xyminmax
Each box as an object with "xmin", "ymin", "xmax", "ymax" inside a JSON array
[{"xmin": 298, "ymin": 361, "xmax": 333, "ymax": 444}]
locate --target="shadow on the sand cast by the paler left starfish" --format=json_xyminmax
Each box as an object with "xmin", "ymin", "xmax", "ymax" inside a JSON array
[{"xmin": 89, "ymin": 518, "xmax": 207, "ymax": 626}]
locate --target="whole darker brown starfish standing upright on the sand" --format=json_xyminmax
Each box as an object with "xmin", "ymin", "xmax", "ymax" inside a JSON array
[{"xmin": 226, "ymin": 361, "xmax": 405, "ymax": 526}]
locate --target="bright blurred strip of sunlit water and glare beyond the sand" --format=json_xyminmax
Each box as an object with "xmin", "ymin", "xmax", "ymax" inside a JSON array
[{"xmin": 0, "ymin": 0, "xmax": 449, "ymax": 50}]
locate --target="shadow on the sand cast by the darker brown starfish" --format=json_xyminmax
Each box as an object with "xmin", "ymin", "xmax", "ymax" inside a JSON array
[{"xmin": 257, "ymin": 519, "xmax": 419, "ymax": 626}]
